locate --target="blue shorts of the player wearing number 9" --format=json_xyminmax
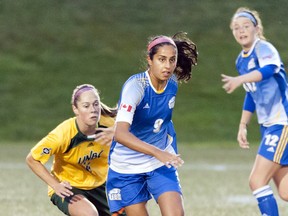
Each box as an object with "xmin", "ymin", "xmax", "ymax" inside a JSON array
[{"xmin": 106, "ymin": 166, "xmax": 182, "ymax": 212}]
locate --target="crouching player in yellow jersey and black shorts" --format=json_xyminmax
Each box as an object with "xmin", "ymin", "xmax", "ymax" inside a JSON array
[{"xmin": 26, "ymin": 84, "xmax": 124, "ymax": 216}]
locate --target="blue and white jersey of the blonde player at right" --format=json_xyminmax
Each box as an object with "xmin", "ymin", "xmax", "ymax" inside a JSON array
[{"xmin": 236, "ymin": 40, "xmax": 288, "ymax": 127}]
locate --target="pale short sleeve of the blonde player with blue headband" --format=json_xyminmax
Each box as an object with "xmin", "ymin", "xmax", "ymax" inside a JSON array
[{"xmin": 256, "ymin": 42, "xmax": 281, "ymax": 73}]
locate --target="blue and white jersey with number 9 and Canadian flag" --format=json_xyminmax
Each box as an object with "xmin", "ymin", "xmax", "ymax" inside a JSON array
[{"xmin": 109, "ymin": 71, "xmax": 178, "ymax": 174}]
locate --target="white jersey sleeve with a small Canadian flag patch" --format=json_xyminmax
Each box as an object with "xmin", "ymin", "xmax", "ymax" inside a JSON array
[{"xmin": 116, "ymin": 77, "xmax": 144, "ymax": 124}]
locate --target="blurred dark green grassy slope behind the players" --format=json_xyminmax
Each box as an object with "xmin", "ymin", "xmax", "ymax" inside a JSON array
[{"xmin": 0, "ymin": 0, "xmax": 288, "ymax": 146}]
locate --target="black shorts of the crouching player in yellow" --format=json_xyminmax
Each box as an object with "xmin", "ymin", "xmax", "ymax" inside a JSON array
[{"xmin": 51, "ymin": 184, "xmax": 111, "ymax": 216}]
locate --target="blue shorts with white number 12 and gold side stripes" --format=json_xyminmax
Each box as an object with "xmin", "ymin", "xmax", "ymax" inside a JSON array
[{"xmin": 258, "ymin": 125, "xmax": 288, "ymax": 166}]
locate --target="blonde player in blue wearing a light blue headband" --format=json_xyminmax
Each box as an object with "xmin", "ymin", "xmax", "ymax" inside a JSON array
[{"xmin": 222, "ymin": 8, "xmax": 288, "ymax": 216}]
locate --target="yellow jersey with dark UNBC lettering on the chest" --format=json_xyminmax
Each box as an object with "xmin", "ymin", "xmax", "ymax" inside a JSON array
[{"xmin": 31, "ymin": 116, "xmax": 114, "ymax": 196}]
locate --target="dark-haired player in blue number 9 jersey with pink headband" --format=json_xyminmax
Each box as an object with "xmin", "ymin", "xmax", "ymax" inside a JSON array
[{"xmin": 107, "ymin": 33, "xmax": 197, "ymax": 216}]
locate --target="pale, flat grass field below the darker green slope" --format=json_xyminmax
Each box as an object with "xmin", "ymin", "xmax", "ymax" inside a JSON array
[{"xmin": 0, "ymin": 143, "xmax": 288, "ymax": 216}]
